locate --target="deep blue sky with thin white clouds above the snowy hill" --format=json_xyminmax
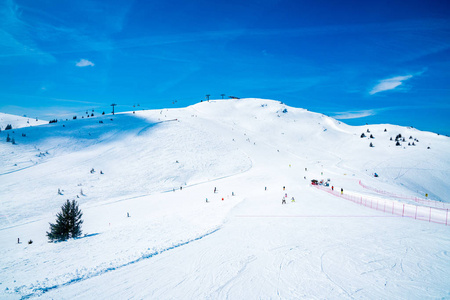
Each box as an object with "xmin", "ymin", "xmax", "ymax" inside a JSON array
[{"xmin": 0, "ymin": 0, "xmax": 450, "ymax": 135}]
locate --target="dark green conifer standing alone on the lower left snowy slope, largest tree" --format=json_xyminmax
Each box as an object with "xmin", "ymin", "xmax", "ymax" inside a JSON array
[{"xmin": 47, "ymin": 199, "xmax": 83, "ymax": 242}]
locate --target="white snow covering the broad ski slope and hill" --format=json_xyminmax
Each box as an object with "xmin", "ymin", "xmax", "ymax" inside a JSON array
[{"xmin": 0, "ymin": 99, "xmax": 450, "ymax": 299}]
